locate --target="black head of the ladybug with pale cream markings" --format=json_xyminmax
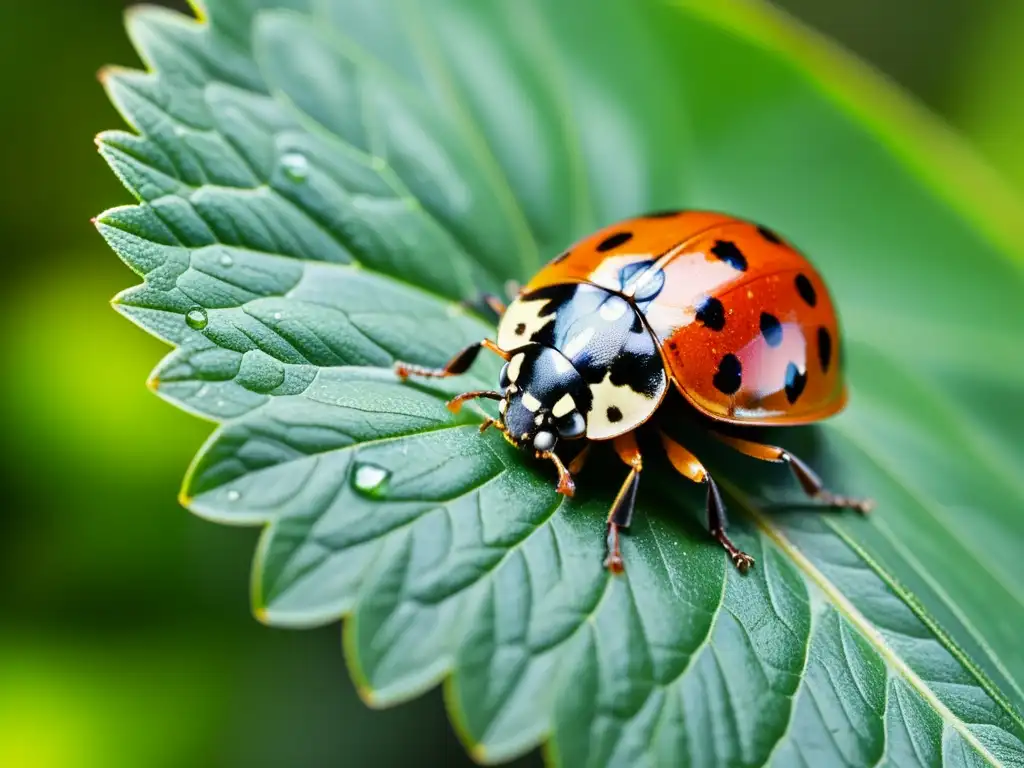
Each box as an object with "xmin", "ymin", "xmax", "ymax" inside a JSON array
[{"xmin": 498, "ymin": 344, "xmax": 591, "ymax": 454}]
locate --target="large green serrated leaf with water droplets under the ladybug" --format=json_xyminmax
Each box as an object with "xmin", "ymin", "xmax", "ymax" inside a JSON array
[{"xmin": 97, "ymin": 0, "xmax": 1024, "ymax": 768}]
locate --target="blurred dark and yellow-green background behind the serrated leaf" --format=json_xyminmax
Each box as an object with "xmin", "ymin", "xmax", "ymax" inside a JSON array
[{"xmin": 0, "ymin": 0, "xmax": 1024, "ymax": 768}]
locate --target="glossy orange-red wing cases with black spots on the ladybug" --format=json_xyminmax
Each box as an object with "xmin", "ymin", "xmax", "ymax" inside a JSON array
[{"xmin": 522, "ymin": 211, "xmax": 847, "ymax": 426}]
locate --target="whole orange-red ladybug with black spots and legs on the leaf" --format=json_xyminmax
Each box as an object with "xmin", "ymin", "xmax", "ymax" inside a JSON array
[{"xmin": 395, "ymin": 211, "xmax": 870, "ymax": 572}]
